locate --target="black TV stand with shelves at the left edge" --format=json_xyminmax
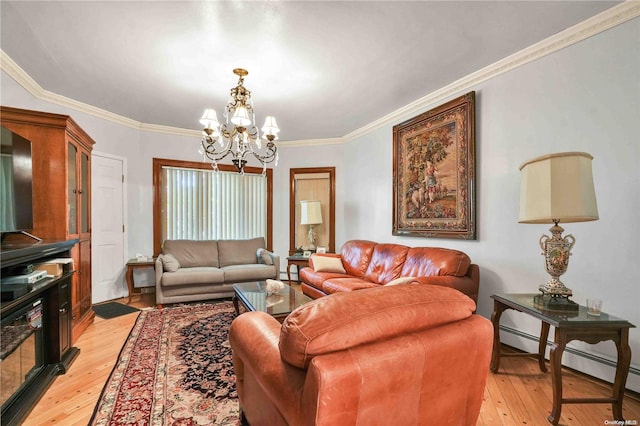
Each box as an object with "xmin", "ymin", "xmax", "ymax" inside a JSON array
[{"xmin": 0, "ymin": 239, "xmax": 80, "ymax": 426}]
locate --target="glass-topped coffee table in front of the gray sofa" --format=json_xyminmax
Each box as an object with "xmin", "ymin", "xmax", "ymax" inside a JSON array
[{"xmin": 232, "ymin": 281, "xmax": 313, "ymax": 322}]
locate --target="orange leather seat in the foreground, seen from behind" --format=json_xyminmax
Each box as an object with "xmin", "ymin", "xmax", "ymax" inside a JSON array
[{"xmin": 229, "ymin": 284, "xmax": 493, "ymax": 426}]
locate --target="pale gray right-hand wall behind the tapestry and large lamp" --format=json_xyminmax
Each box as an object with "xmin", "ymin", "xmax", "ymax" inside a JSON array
[{"xmin": 338, "ymin": 18, "xmax": 640, "ymax": 390}]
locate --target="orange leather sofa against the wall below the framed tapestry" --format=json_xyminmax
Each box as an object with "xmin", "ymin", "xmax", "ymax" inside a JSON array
[{"xmin": 299, "ymin": 240, "xmax": 480, "ymax": 302}]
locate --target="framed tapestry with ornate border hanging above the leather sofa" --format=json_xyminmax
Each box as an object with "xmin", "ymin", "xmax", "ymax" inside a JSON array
[{"xmin": 393, "ymin": 92, "xmax": 476, "ymax": 240}]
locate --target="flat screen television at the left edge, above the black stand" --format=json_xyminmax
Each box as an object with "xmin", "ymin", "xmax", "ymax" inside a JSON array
[{"xmin": 0, "ymin": 126, "xmax": 33, "ymax": 236}]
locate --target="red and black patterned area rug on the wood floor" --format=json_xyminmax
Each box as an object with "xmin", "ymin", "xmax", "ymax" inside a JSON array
[{"xmin": 90, "ymin": 301, "xmax": 240, "ymax": 426}]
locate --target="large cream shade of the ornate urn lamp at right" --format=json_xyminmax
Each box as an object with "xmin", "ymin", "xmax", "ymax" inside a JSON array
[{"xmin": 518, "ymin": 152, "xmax": 598, "ymax": 223}]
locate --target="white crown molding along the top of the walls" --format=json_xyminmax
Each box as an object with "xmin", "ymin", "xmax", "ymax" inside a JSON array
[{"xmin": 0, "ymin": 0, "xmax": 640, "ymax": 147}]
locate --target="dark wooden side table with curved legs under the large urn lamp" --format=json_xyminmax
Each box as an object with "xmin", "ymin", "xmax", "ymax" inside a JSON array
[{"xmin": 491, "ymin": 293, "xmax": 635, "ymax": 425}]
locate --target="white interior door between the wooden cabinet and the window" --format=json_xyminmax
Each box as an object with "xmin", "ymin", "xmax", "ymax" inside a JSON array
[{"xmin": 91, "ymin": 153, "xmax": 127, "ymax": 303}]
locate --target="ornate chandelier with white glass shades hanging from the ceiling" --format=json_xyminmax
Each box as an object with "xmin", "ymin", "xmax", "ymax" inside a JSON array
[{"xmin": 199, "ymin": 68, "xmax": 280, "ymax": 173}]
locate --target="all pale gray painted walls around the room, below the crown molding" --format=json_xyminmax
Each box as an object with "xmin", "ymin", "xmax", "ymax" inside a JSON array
[{"xmin": 0, "ymin": 18, "xmax": 640, "ymax": 391}]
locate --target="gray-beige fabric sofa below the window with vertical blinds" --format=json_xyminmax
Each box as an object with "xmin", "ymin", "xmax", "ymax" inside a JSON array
[{"xmin": 155, "ymin": 238, "xmax": 280, "ymax": 307}]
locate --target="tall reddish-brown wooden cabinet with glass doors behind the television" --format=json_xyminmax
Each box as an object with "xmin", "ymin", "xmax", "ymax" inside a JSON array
[{"xmin": 0, "ymin": 107, "xmax": 95, "ymax": 343}]
